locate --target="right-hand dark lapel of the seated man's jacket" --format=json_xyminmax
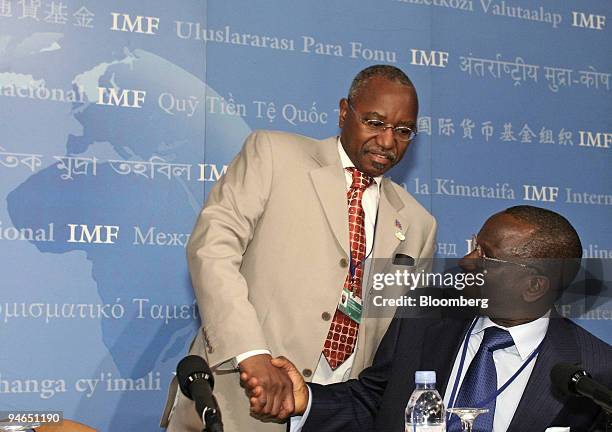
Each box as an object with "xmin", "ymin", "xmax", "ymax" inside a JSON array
[{"xmin": 508, "ymin": 313, "xmax": 581, "ymax": 432}]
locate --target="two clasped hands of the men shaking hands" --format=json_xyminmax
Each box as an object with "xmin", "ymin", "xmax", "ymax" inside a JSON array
[{"xmin": 240, "ymin": 354, "xmax": 309, "ymax": 421}]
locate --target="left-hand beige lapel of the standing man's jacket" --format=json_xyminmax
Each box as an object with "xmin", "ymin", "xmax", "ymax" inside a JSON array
[{"xmin": 310, "ymin": 137, "xmax": 350, "ymax": 257}]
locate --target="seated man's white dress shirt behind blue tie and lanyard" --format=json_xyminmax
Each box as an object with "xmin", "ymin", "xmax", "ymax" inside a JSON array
[{"xmin": 444, "ymin": 313, "xmax": 550, "ymax": 432}]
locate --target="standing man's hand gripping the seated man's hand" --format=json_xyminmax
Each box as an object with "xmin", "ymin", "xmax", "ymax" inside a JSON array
[{"xmin": 239, "ymin": 354, "xmax": 295, "ymax": 420}]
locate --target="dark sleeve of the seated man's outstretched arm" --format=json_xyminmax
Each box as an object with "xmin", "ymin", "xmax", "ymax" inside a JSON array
[{"xmin": 302, "ymin": 312, "xmax": 405, "ymax": 432}]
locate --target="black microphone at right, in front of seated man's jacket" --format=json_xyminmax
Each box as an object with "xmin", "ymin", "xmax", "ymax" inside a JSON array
[{"xmin": 550, "ymin": 363, "xmax": 612, "ymax": 413}]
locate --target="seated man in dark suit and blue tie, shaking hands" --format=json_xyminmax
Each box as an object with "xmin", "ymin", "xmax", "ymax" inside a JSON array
[{"xmin": 241, "ymin": 206, "xmax": 612, "ymax": 432}]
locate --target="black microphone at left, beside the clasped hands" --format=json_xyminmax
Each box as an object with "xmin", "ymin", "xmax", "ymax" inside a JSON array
[{"xmin": 176, "ymin": 355, "xmax": 223, "ymax": 432}]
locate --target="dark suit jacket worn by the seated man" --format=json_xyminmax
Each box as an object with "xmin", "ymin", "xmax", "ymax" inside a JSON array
[{"xmin": 303, "ymin": 308, "xmax": 612, "ymax": 432}]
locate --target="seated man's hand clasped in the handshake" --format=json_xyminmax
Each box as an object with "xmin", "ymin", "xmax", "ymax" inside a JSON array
[{"xmin": 241, "ymin": 357, "xmax": 309, "ymax": 420}]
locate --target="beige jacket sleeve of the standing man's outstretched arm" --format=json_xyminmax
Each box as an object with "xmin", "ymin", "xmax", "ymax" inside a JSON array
[{"xmin": 187, "ymin": 132, "xmax": 273, "ymax": 367}]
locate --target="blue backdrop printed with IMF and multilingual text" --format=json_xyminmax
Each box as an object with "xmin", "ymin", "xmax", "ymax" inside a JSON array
[{"xmin": 0, "ymin": 0, "xmax": 612, "ymax": 431}]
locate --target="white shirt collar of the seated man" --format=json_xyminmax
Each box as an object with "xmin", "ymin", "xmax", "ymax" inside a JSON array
[{"xmin": 472, "ymin": 311, "xmax": 550, "ymax": 360}]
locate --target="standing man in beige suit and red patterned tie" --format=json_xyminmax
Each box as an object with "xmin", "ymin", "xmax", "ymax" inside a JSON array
[{"xmin": 162, "ymin": 65, "xmax": 436, "ymax": 432}]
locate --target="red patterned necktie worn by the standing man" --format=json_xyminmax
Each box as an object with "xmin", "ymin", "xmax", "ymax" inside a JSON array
[{"xmin": 323, "ymin": 168, "xmax": 374, "ymax": 370}]
